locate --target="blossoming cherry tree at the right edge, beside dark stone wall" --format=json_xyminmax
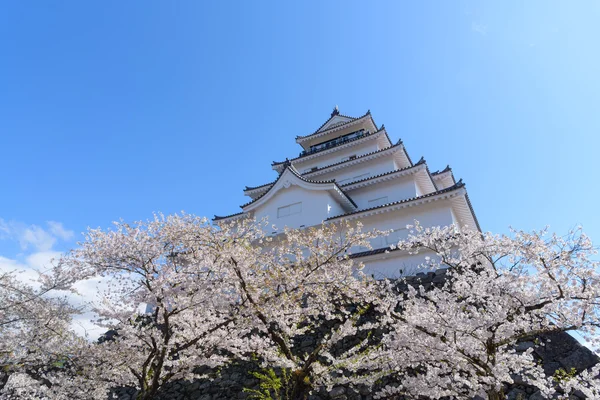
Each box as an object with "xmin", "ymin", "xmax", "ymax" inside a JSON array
[{"xmin": 372, "ymin": 224, "xmax": 600, "ymax": 400}]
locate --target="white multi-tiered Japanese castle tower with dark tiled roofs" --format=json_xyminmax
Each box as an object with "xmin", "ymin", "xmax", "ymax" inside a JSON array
[{"xmin": 213, "ymin": 106, "xmax": 480, "ymax": 278}]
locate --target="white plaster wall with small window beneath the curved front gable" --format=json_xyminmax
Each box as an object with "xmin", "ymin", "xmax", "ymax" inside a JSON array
[{"xmin": 254, "ymin": 185, "xmax": 344, "ymax": 234}]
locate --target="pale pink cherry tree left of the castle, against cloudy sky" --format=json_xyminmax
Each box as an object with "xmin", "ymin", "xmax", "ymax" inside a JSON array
[{"xmin": 55, "ymin": 214, "xmax": 244, "ymax": 400}]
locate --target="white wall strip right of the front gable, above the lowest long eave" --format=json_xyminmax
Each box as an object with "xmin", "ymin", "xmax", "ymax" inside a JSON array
[{"xmin": 348, "ymin": 175, "xmax": 417, "ymax": 209}]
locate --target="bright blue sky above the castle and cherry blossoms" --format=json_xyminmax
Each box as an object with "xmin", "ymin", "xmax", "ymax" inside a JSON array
[{"xmin": 0, "ymin": 1, "xmax": 600, "ymax": 276}]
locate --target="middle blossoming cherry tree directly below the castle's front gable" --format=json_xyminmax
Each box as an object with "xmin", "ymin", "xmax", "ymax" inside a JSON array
[{"xmin": 215, "ymin": 223, "xmax": 381, "ymax": 400}]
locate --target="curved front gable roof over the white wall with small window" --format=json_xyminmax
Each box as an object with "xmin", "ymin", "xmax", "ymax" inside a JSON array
[{"xmin": 240, "ymin": 163, "xmax": 358, "ymax": 212}]
